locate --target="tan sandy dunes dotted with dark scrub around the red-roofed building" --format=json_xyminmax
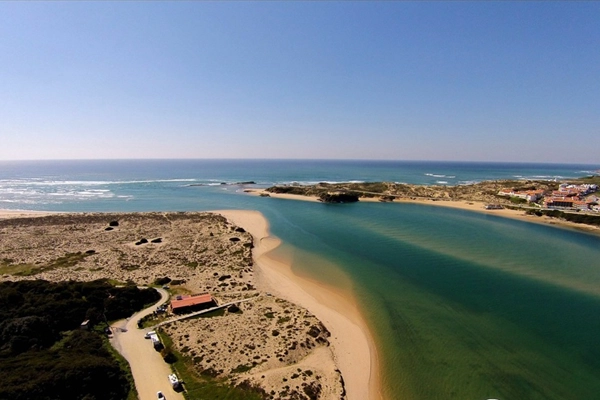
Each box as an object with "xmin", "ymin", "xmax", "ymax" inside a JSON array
[{"xmin": 0, "ymin": 212, "xmax": 352, "ymax": 399}]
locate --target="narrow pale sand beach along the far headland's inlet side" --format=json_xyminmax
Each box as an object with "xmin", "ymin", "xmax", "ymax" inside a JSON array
[{"xmin": 246, "ymin": 190, "xmax": 600, "ymax": 235}]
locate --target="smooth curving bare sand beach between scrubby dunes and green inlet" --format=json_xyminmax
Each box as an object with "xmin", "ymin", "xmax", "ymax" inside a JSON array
[{"xmin": 217, "ymin": 211, "xmax": 382, "ymax": 400}]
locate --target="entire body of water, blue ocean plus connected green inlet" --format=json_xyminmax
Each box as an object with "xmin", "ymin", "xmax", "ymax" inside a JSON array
[{"xmin": 0, "ymin": 160, "xmax": 600, "ymax": 400}]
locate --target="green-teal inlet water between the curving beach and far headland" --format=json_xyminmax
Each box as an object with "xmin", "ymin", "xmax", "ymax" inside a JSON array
[{"xmin": 264, "ymin": 200, "xmax": 600, "ymax": 399}]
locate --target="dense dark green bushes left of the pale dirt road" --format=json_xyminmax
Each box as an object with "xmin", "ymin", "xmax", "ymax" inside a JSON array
[{"xmin": 0, "ymin": 280, "xmax": 160, "ymax": 400}]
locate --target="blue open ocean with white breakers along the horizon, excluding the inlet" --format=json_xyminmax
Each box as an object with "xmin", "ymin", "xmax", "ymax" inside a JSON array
[{"xmin": 0, "ymin": 160, "xmax": 600, "ymax": 211}]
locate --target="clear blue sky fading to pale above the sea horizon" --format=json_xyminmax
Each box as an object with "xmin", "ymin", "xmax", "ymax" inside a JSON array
[{"xmin": 0, "ymin": 1, "xmax": 600, "ymax": 163}]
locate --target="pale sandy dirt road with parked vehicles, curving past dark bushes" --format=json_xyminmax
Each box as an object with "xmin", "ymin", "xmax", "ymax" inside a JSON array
[{"xmin": 110, "ymin": 289, "xmax": 184, "ymax": 400}]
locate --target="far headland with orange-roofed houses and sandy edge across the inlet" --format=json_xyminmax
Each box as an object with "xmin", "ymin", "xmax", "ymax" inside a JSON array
[{"xmin": 245, "ymin": 176, "xmax": 600, "ymax": 234}]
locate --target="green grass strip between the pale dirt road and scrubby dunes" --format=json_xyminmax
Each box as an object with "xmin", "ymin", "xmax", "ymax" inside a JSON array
[{"xmin": 159, "ymin": 332, "xmax": 267, "ymax": 400}]
